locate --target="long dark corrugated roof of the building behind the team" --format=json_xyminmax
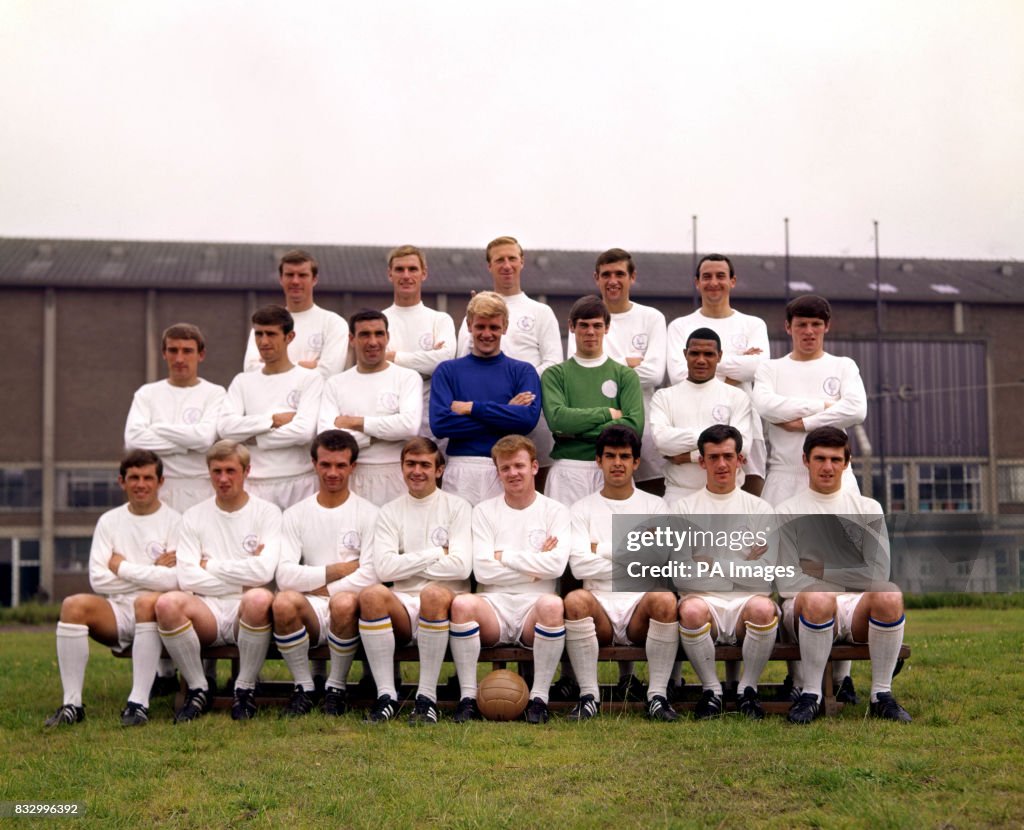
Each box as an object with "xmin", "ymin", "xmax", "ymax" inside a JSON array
[{"xmin": 0, "ymin": 238, "xmax": 1024, "ymax": 303}]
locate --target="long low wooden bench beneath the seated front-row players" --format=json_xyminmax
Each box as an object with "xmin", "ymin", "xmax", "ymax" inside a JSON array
[{"xmin": 113, "ymin": 643, "xmax": 910, "ymax": 714}]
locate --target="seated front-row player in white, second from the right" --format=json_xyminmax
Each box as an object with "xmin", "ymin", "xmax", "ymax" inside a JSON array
[{"xmin": 675, "ymin": 427, "xmax": 778, "ymax": 720}]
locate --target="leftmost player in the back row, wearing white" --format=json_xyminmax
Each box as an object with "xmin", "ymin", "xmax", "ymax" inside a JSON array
[{"xmin": 244, "ymin": 250, "xmax": 348, "ymax": 378}]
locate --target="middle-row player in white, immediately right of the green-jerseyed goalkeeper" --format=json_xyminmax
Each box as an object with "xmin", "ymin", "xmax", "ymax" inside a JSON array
[{"xmin": 649, "ymin": 329, "xmax": 754, "ymax": 508}]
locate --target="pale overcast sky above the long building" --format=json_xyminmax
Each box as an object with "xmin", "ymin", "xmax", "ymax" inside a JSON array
[{"xmin": 0, "ymin": 0, "xmax": 1024, "ymax": 259}]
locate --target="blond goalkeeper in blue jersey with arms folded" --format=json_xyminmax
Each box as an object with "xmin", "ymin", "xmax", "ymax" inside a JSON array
[{"xmin": 430, "ymin": 291, "xmax": 541, "ymax": 505}]
